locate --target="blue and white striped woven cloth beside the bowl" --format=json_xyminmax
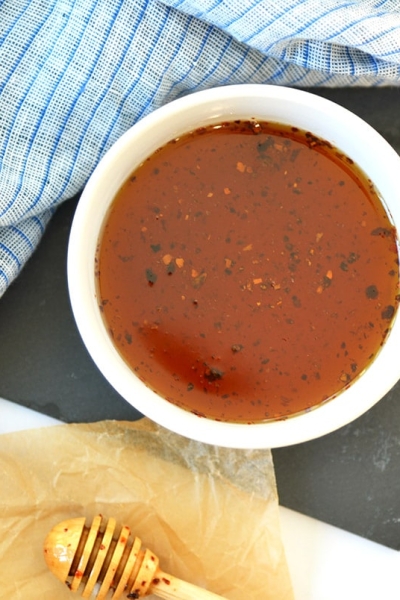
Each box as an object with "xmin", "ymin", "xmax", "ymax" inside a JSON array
[{"xmin": 0, "ymin": 0, "xmax": 400, "ymax": 296}]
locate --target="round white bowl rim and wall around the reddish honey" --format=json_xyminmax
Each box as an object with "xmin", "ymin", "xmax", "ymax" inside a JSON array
[{"xmin": 68, "ymin": 85, "xmax": 400, "ymax": 448}]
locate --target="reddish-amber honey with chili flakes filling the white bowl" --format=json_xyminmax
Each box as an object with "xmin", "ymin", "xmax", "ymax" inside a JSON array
[{"xmin": 97, "ymin": 120, "xmax": 399, "ymax": 422}]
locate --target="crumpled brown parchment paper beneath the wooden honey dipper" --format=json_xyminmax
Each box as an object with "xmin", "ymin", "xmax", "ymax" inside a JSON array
[{"xmin": 0, "ymin": 419, "xmax": 293, "ymax": 600}]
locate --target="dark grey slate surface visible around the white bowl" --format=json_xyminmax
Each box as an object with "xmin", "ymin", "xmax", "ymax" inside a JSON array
[{"xmin": 0, "ymin": 89, "xmax": 400, "ymax": 550}]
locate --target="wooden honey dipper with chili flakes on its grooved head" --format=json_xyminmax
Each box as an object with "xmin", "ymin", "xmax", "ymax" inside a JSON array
[{"xmin": 44, "ymin": 515, "xmax": 227, "ymax": 600}]
